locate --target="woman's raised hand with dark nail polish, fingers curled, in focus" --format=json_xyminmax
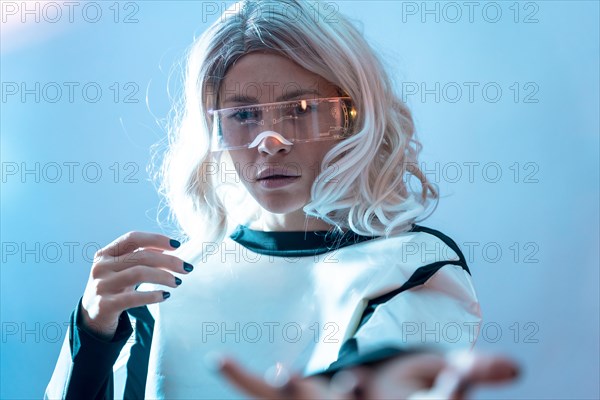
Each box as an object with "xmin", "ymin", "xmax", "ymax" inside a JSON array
[{"xmin": 81, "ymin": 232, "xmax": 193, "ymax": 340}]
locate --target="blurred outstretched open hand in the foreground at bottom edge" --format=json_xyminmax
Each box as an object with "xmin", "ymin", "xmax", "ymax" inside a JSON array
[{"xmin": 219, "ymin": 352, "xmax": 518, "ymax": 400}]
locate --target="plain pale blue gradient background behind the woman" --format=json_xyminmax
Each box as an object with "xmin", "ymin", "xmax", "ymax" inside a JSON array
[{"xmin": 0, "ymin": 1, "xmax": 600, "ymax": 399}]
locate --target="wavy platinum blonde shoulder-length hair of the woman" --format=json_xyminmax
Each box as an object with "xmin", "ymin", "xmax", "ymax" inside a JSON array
[{"xmin": 149, "ymin": 0, "xmax": 439, "ymax": 241}]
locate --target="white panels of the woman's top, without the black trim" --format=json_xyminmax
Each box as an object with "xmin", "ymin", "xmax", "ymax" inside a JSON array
[{"xmin": 124, "ymin": 225, "xmax": 481, "ymax": 399}]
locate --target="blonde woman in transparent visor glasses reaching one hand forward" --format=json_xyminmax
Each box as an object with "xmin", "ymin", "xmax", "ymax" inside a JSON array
[{"xmin": 46, "ymin": 0, "xmax": 515, "ymax": 399}]
